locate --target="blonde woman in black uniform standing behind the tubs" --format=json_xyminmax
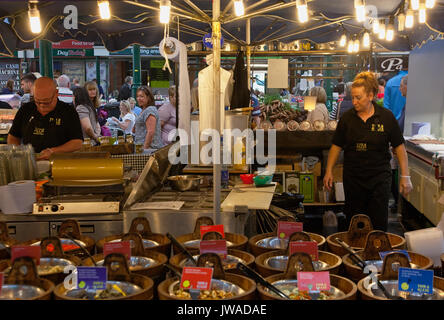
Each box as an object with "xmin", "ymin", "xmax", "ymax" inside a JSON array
[{"xmin": 324, "ymin": 72, "xmax": 412, "ymax": 231}]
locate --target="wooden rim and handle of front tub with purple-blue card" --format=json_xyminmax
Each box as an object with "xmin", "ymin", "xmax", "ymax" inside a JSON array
[{"xmin": 54, "ymin": 253, "xmax": 154, "ymax": 300}]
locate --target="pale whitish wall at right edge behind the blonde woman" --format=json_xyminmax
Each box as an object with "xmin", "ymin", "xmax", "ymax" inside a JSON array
[{"xmin": 404, "ymin": 40, "xmax": 444, "ymax": 138}]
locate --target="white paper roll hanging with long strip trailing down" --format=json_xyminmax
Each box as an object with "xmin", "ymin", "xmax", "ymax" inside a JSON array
[{"xmin": 159, "ymin": 37, "xmax": 191, "ymax": 144}]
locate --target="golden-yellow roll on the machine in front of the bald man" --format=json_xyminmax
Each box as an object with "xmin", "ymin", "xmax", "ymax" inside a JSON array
[{"xmin": 51, "ymin": 158, "xmax": 123, "ymax": 181}]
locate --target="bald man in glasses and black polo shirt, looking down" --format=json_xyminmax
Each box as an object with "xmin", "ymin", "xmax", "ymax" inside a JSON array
[{"xmin": 8, "ymin": 77, "xmax": 83, "ymax": 160}]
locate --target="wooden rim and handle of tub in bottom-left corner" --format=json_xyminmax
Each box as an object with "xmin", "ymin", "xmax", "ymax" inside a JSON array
[{"xmin": 5, "ymin": 257, "xmax": 54, "ymax": 300}]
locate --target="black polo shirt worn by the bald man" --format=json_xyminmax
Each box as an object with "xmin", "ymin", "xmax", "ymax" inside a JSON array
[{"xmin": 9, "ymin": 100, "xmax": 83, "ymax": 153}]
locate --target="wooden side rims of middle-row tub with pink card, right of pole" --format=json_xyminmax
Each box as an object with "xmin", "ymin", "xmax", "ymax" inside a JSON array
[{"xmin": 255, "ymin": 250, "xmax": 342, "ymax": 277}]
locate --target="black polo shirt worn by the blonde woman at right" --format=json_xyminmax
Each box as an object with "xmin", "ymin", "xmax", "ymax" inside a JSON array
[{"xmin": 332, "ymin": 104, "xmax": 405, "ymax": 177}]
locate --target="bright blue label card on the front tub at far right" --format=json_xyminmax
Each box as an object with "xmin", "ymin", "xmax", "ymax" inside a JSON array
[{"xmin": 398, "ymin": 268, "xmax": 434, "ymax": 294}]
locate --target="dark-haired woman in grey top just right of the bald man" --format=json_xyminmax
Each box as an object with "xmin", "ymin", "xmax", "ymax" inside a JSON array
[{"xmin": 73, "ymin": 87, "xmax": 101, "ymax": 144}]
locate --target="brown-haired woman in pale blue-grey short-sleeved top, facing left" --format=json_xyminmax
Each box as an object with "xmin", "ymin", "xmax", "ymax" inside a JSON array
[{"xmin": 134, "ymin": 86, "xmax": 163, "ymax": 149}]
